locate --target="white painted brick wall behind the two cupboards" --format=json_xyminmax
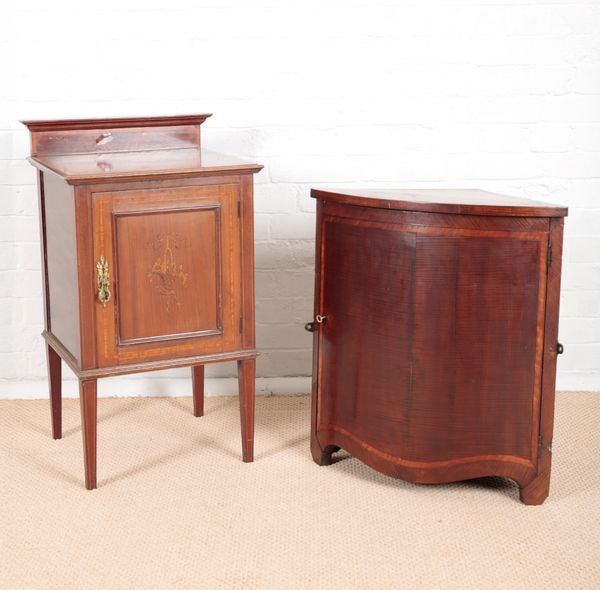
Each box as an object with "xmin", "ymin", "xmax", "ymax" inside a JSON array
[{"xmin": 0, "ymin": 0, "xmax": 600, "ymax": 397}]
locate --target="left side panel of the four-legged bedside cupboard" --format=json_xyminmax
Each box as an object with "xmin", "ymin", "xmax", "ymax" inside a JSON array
[{"xmin": 43, "ymin": 174, "xmax": 81, "ymax": 363}]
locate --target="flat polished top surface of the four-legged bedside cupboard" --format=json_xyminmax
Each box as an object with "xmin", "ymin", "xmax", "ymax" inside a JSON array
[{"xmin": 29, "ymin": 148, "xmax": 262, "ymax": 184}]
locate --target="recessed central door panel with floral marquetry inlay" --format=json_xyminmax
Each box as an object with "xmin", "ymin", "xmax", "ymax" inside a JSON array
[{"xmin": 114, "ymin": 205, "xmax": 222, "ymax": 344}]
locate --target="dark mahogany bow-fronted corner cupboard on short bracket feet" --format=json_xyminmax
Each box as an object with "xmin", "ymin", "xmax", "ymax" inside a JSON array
[{"xmin": 307, "ymin": 190, "xmax": 567, "ymax": 504}]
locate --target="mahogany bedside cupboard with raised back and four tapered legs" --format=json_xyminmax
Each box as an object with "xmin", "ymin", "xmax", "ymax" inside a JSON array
[{"xmin": 23, "ymin": 114, "xmax": 262, "ymax": 489}]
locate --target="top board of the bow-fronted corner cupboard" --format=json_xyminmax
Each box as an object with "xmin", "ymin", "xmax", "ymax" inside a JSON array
[{"xmin": 311, "ymin": 189, "xmax": 568, "ymax": 217}]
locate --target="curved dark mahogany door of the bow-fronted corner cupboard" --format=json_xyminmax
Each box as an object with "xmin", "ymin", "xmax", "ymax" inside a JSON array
[{"xmin": 317, "ymin": 216, "xmax": 548, "ymax": 481}]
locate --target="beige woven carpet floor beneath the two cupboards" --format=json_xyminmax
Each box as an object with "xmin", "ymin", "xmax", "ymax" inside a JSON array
[{"xmin": 0, "ymin": 393, "xmax": 600, "ymax": 590}]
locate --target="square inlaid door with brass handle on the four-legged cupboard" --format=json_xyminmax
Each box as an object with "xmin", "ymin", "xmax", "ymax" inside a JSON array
[{"xmin": 93, "ymin": 184, "xmax": 241, "ymax": 366}]
